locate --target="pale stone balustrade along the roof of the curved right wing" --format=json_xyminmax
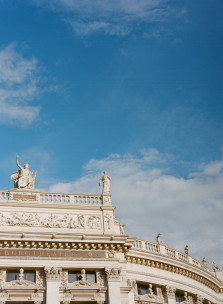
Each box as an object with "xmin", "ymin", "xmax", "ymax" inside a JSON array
[{"xmin": 132, "ymin": 239, "xmax": 208, "ymax": 270}]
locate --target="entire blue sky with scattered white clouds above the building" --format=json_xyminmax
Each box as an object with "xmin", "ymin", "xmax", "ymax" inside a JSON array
[{"xmin": 0, "ymin": 0, "xmax": 223, "ymax": 263}]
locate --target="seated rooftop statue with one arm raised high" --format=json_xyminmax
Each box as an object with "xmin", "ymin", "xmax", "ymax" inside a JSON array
[{"xmin": 11, "ymin": 155, "xmax": 37, "ymax": 189}]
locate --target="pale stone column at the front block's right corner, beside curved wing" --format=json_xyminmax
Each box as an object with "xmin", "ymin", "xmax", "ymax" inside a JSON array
[{"xmin": 105, "ymin": 268, "xmax": 121, "ymax": 304}]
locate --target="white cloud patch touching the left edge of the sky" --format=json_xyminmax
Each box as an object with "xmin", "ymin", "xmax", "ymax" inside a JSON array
[{"xmin": 0, "ymin": 44, "xmax": 40, "ymax": 126}]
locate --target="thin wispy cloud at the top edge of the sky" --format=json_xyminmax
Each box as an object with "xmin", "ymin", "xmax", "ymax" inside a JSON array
[{"xmin": 35, "ymin": 0, "xmax": 178, "ymax": 36}]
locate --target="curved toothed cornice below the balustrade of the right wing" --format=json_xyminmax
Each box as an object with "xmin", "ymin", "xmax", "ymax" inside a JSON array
[{"xmin": 126, "ymin": 255, "xmax": 221, "ymax": 293}]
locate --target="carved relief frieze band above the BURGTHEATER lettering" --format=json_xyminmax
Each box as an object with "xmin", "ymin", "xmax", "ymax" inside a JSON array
[{"xmin": 0, "ymin": 212, "xmax": 102, "ymax": 230}]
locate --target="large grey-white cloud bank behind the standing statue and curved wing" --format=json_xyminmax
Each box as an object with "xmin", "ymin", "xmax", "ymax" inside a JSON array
[{"xmin": 50, "ymin": 150, "xmax": 223, "ymax": 266}]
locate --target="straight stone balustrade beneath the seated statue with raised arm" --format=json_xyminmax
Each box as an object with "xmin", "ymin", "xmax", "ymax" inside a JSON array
[{"xmin": 0, "ymin": 190, "xmax": 102, "ymax": 206}]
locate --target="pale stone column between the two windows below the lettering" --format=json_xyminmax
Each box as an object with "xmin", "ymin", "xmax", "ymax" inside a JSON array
[{"xmin": 45, "ymin": 267, "xmax": 62, "ymax": 304}]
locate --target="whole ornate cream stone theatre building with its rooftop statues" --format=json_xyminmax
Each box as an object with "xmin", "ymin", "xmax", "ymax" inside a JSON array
[{"xmin": 0, "ymin": 158, "xmax": 223, "ymax": 304}]
